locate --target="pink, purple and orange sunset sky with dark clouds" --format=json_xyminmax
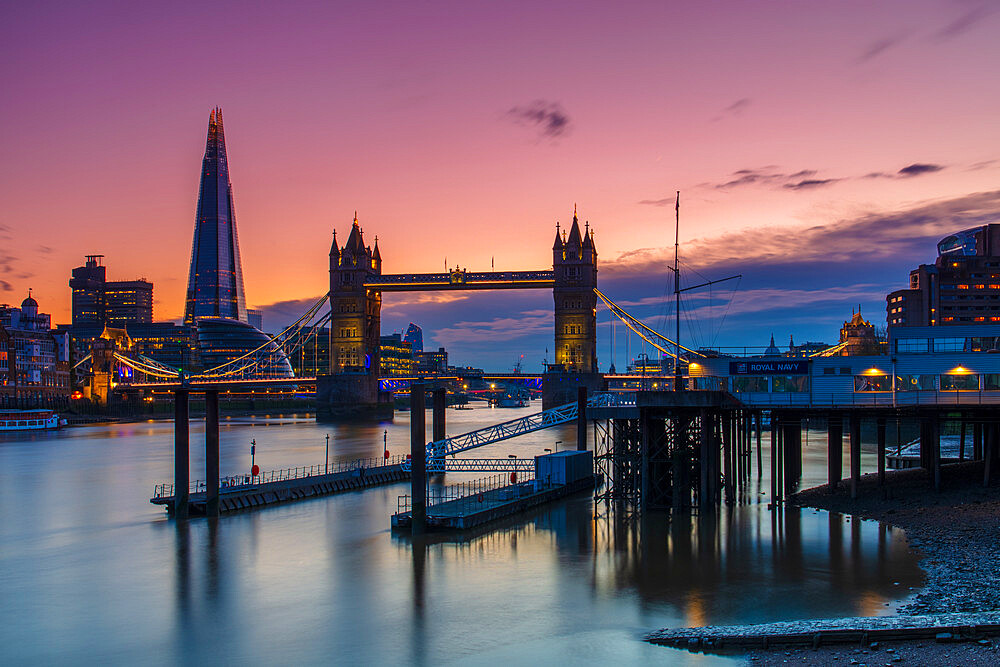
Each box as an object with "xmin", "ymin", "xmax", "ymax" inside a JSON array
[{"xmin": 0, "ymin": 0, "xmax": 1000, "ymax": 370}]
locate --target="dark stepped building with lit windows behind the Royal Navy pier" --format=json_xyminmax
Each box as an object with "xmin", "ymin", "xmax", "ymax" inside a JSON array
[{"xmin": 886, "ymin": 224, "xmax": 1000, "ymax": 327}]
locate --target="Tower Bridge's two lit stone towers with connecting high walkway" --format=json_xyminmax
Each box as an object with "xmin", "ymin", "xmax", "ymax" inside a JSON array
[{"xmin": 316, "ymin": 210, "xmax": 603, "ymax": 418}]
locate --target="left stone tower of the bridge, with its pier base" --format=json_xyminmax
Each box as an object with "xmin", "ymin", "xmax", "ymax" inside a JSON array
[{"xmin": 316, "ymin": 214, "xmax": 392, "ymax": 416}]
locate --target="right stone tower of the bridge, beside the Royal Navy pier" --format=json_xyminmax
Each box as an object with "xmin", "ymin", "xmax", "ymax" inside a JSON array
[{"xmin": 543, "ymin": 207, "xmax": 603, "ymax": 407}]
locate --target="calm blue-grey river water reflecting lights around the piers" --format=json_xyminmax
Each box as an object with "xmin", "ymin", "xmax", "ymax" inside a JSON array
[{"xmin": 0, "ymin": 403, "xmax": 921, "ymax": 665}]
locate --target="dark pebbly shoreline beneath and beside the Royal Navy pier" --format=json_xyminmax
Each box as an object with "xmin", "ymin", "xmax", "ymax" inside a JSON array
[{"xmin": 747, "ymin": 461, "xmax": 1000, "ymax": 665}]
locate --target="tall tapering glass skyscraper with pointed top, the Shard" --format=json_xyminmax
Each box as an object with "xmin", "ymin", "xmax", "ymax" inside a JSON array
[{"xmin": 184, "ymin": 107, "xmax": 247, "ymax": 324}]
